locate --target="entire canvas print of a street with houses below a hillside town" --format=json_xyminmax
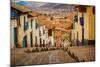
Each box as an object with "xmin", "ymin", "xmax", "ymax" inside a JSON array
[{"xmin": 10, "ymin": 2, "xmax": 95, "ymax": 65}]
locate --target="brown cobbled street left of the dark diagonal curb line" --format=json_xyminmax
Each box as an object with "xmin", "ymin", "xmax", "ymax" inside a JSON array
[{"xmin": 11, "ymin": 49, "xmax": 76, "ymax": 65}]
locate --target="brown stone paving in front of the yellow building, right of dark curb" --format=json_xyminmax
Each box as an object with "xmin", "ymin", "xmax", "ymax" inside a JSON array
[{"xmin": 68, "ymin": 46, "xmax": 95, "ymax": 62}]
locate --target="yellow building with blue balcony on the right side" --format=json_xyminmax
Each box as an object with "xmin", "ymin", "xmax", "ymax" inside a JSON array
[{"xmin": 71, "ymin": 6, "xmax": 95, "ymax": 45}]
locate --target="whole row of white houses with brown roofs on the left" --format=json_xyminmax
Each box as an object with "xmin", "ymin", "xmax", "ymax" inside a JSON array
[{"xmin": 10, "ymin": 3, "xmax": 54, "ymax": 48}]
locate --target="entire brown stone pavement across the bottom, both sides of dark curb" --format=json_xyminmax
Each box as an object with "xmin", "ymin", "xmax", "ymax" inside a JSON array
[{"xmin": 11, "ymin": 46, "xmax": 95, "ymax": 66}]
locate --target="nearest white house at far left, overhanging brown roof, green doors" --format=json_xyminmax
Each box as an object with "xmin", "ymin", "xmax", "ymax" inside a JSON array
[{"xmin": 10, "ymin": 3, "xmax": 31, "ymax": 48}]
